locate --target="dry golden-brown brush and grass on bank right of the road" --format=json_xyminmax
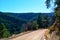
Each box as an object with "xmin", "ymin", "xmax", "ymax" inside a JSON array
[{"xmin": 45, "ymin": 20, "xmax": 60, "ymax": 40}]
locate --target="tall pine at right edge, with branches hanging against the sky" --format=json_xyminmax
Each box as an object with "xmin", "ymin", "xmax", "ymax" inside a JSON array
[{"xmin": 46, "ymin": 0, "xmax": 60, "ymax": 31}]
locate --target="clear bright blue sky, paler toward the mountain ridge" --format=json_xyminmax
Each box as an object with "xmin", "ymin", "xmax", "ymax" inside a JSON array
[{"xmin": 0, "ymin": 0, "xmax": 52, "ymax": 12}]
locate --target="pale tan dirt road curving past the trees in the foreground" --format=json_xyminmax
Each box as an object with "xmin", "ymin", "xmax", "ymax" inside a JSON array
[{"xmin": 10, "ymin": 29, "xmax": 47, "ymax": 40}]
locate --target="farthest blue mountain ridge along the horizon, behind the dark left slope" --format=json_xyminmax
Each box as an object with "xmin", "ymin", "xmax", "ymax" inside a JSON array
[{"xmin": 0, "ymin": 13, "xmax": 54, "ymax": 21}]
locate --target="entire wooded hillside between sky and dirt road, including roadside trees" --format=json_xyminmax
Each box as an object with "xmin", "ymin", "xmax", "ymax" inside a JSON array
[{"xmin": 0, "ymin": 12, "xmax": 54, "ymax": 35}]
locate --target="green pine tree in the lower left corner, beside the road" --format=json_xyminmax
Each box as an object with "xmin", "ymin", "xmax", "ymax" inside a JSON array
[{"xmin": 0, "ymin": 23, "xmax": 10, "ymax": 38}]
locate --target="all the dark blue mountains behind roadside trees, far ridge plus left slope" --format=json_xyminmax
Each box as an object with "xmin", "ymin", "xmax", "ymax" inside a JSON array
[{"xmin": 0, "ymin": 12, "xmax": 54, "ymax": 34}]
